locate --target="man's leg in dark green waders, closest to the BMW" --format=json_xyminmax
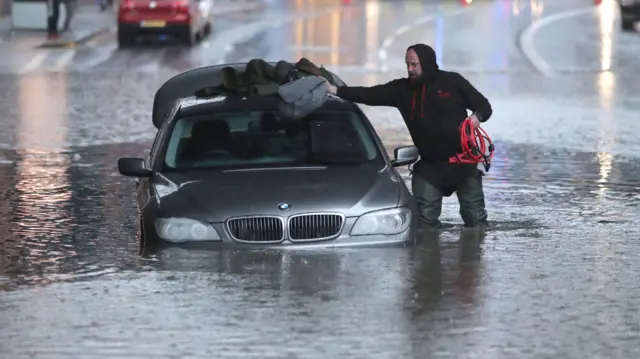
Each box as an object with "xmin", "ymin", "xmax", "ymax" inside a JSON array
[{"xmin": 411, "ymin": 173, "xmax": 442, "ymax": 229}]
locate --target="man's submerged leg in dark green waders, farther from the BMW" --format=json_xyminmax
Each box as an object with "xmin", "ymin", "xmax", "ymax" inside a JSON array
[{"xmin": 456, "ymin": 171, "xmax": 488, "ymax": 227}]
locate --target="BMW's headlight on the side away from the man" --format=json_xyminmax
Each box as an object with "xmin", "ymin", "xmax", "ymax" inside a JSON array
[{"xmin": 154, "ymin": 218, "xmax": 220, "ymax": 243}]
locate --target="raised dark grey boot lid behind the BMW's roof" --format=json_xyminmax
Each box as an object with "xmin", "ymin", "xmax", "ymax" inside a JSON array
[{"xmin": 152, "ymin": 62, "xmax": 345, "ymax": 128}]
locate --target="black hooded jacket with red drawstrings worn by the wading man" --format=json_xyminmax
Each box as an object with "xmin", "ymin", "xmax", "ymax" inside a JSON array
[{"xmin": 336, "ymin": 44, "xmax": 493, "ymax": 195}]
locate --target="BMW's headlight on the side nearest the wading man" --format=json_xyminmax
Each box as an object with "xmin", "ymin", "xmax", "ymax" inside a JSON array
[{"xmin": 351, "ymin": 207, "xmax": 411, "ymax": 236}]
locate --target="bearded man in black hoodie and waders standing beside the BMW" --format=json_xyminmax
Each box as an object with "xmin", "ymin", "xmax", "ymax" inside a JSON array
[{"xmin": 328, "ymin": 44, "xmax": 493, "ymax": 229}]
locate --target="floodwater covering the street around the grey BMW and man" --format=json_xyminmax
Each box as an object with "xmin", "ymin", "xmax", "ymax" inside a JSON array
[{"xmin": 0, "ymin": 0, "xmax": 640, "ymax": 359}]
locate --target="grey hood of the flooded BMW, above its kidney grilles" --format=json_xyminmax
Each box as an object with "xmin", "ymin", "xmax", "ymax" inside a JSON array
[{"xmin": 155, "ymin": 166, "xmax": 400, "ymax": 222}]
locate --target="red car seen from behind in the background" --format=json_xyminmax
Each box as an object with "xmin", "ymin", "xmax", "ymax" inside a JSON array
[{"xmin": 118, "ymin": 0, "xmax": 213, "ymax": 46}]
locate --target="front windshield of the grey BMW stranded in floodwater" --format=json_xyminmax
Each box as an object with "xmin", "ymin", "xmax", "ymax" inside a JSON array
[{"xmin": 165, "ymin": 110, "xmax": 382, "ymax": 171}]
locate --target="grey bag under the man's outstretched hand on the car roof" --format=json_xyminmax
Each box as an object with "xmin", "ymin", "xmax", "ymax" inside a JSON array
[{"xmin": 278, "ymin": 76, "xmax": 328, "ymax": 120}]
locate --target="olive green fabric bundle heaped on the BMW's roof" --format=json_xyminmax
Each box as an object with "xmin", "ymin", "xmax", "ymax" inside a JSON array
[{"xmin": 195, "ymin": 57, "xmax": 336, "ymax": 97}]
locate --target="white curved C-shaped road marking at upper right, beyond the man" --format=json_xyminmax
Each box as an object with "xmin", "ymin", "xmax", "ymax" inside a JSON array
[{"xmin": 519, "ymin": 6, "xmax": 597, "ymax": 77}]
